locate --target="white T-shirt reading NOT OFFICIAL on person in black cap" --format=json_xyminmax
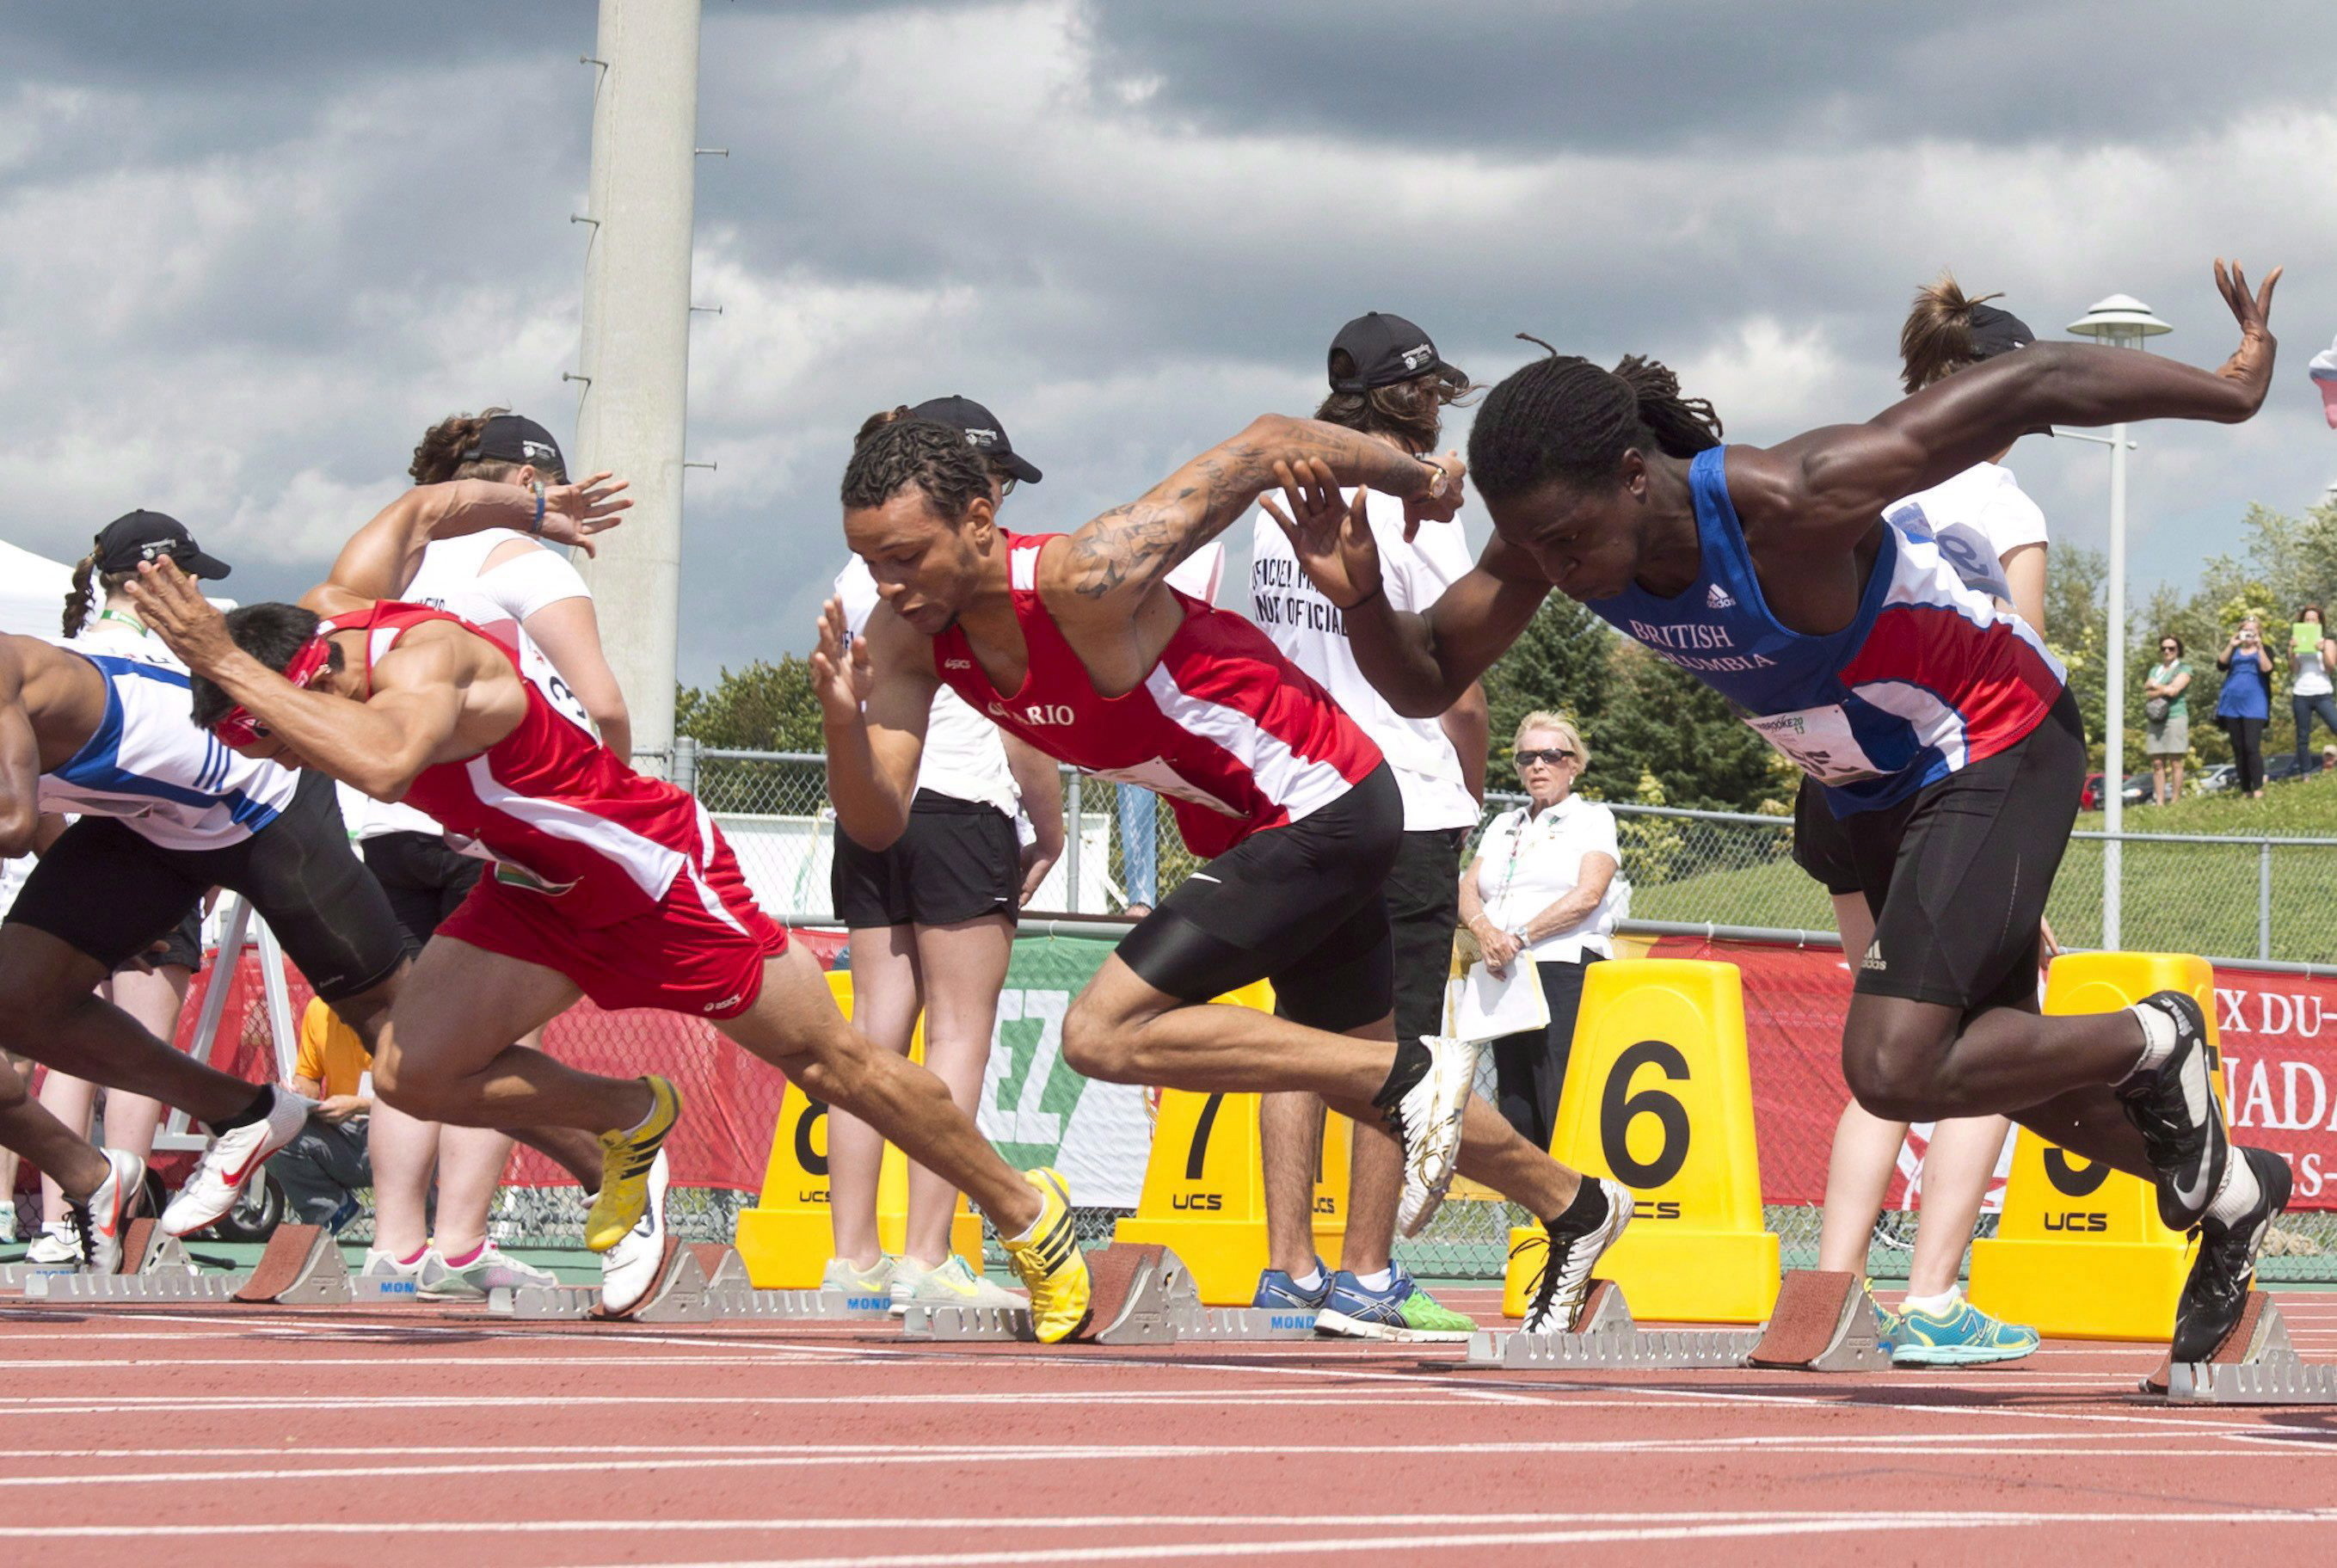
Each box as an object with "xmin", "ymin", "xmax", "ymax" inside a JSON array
[{"xmin": 1251, "ymin": 491, "xmax": 1477, "ymax": 832}]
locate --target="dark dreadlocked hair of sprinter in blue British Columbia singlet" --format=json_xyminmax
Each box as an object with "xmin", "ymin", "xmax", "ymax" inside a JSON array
[{"xmin": 1467, "ymin": 332, "xmax": 1720, "ymax": 500}]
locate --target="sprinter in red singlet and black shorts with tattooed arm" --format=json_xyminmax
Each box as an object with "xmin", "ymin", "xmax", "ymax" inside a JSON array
[{"xmin": 814, "ymin": 416, "xmax": 1631, "ymax": 1332}]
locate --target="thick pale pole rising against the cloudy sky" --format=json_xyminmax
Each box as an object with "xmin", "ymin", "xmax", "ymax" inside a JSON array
[{"xmin": 575, "ymin": 0, "xmax": 698, "ymax": 750}]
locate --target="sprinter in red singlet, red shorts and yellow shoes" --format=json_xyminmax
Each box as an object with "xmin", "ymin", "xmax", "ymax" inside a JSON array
[{"xmin": 138, "ymin": 475, "xmax": 1086, "ymax": 1341}]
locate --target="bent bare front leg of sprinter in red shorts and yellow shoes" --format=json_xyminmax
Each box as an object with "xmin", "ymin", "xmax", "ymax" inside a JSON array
[{"xmin": 376, "ymin": 935, "xmax": 655, "ymax": 1135}]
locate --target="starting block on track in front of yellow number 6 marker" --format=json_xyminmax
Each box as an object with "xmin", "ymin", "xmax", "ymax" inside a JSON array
[{"xmin": 1467, "ymin": 1269, "xmax": 1891, "ymax": 1372}]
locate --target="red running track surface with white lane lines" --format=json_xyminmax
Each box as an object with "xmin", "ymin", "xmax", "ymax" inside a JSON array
[{"xmin": 0, "ymin": 1292, "xmax": 2337, "ymax": 1568}]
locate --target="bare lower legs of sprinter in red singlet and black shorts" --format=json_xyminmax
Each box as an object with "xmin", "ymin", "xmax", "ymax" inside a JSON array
[{"xmin": 1063, "ymin": 956, "xmax": 1579, "ymax": 1220}]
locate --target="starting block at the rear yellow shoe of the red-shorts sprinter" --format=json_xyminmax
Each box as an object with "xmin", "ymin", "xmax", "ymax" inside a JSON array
[{"xmin": 902, "ymin": 1241, "xmax": 1316, "ymax": 1346}]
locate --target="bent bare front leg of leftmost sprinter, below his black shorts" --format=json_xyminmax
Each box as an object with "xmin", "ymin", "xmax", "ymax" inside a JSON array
[{"xmin": 0, "ymin": 920, "xmax": 268, "ymax": 1122}]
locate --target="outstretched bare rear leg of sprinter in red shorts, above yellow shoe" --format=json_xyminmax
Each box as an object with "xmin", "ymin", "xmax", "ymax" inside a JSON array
[{"xmin": 720, "ymin": 946, "xmax": 1040, "ymax": 1236}]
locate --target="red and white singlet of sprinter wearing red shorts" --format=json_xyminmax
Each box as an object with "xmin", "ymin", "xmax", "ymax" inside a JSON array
[{"xmin": 318, "ymin": 600, "xmax": 717, "ymax": 925}]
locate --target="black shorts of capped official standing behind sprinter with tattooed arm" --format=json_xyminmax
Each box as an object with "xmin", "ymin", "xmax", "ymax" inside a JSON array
[{"xmin": 827, "ymin": 790, "xmax": 1021, "ymax": 930}]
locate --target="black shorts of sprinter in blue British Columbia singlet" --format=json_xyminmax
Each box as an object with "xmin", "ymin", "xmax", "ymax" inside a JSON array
[{"xmin": 1821, "ymin": 689, "xmax": 2085, "ymax": 1014}]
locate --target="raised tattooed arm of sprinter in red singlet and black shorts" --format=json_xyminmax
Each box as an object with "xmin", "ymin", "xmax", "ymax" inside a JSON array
[{"xmin": 1047, "ymin": 414, "xmax": 1461, "ymax": 617}]
